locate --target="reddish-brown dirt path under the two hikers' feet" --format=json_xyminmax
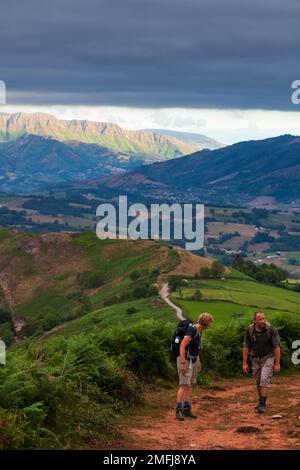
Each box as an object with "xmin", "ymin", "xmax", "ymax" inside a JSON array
[{"xmin": 107, "ymin": 375, "xmax": 300, "ymax": 450}]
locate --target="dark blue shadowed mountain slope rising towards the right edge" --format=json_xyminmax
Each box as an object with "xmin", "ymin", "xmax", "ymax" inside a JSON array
[{"xmin": 100, "ymin": 135, "xmax": 300, "ymax": 204}]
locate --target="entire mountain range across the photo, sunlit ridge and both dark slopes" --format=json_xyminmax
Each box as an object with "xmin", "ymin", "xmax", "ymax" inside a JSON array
[{"xmin": 0, "ymin": 113, "xmax": 300, "ymax": 205}]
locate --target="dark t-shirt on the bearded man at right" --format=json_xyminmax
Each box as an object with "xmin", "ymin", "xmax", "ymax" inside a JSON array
[{"xmin": 244, "ymin": 325, "xmax": 280, "ymax": 357}]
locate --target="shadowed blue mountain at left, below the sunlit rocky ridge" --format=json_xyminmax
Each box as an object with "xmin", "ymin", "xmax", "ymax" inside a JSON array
[{"xmin": 0, "ymin": 134, "xmax": 144, "ymax": 194}]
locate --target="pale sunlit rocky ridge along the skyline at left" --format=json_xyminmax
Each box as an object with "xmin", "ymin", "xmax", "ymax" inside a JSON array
[{"xmin": 0, "ymin": 113, "xmax": 197, "ymax": 161}]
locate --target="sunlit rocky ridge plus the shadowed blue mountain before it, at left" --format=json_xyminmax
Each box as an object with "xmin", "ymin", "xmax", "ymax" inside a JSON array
[{"xmin": 0, "ymin": 113, "xmax": 221, "ymax": 193}]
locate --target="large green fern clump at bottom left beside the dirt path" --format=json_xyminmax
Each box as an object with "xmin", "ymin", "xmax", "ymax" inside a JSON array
[{"xmin": 0, "ymin": 335, "xmax": 142, "ymax": 449}]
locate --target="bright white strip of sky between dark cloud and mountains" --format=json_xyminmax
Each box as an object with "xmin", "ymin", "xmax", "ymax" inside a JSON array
[{"xmin": 0, "ymin": 104, "xmax": 300, "ymax": 145}]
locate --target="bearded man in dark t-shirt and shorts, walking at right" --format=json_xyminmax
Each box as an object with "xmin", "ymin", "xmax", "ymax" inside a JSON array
[{"xmin": 243, "ymin": 312, "xmax": 280, "ymax": 413}]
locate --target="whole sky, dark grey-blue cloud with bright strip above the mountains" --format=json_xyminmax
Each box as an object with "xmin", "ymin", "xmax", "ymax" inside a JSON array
[{"xmin": 0, "ymin": 0, "xmax": 300, "ymax": 143}]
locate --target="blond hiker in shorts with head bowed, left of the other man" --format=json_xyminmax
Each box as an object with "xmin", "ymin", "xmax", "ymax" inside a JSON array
[{"xmin": 175, "ymin": 313, "xmax": 214, "ymax": 421}]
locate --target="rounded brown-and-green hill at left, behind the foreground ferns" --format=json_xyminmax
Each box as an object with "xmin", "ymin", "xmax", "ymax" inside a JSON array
[{"xmin": 0, "ymin": 229, "xmax": 179, "ymax": 336}]
